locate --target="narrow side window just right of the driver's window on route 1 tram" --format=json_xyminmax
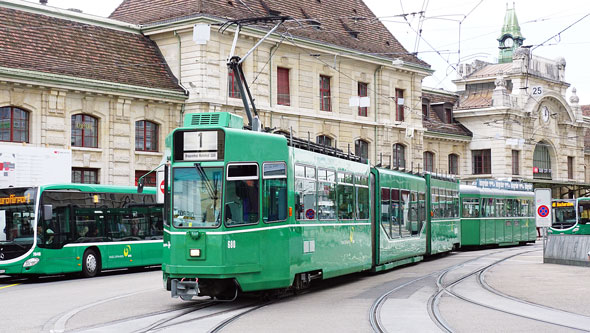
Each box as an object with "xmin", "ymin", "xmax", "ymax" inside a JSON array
[{"xmin": 262, "ymin": 162, "xmax": 287, "ymax": 222}]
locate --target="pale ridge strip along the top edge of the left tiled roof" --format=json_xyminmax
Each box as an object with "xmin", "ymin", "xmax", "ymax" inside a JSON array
[{"xmin": 0, "ymin": 0, "xmax": 141, "ymax": 34}]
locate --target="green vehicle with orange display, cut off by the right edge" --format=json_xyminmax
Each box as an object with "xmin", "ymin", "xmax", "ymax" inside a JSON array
[{"xmin": 547, "ymin": 197, "xmax": 590, "ymax": 235}]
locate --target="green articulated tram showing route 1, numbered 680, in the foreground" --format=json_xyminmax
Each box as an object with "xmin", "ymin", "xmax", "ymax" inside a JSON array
[{"xmin": 162, "ymin": 113, "xmax": 460, "ymax": 299}]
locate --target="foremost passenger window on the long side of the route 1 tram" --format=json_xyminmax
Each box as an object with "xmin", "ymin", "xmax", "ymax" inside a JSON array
[{"xmin": 295, "ymin": 164, "xmax": 316, "ymax": 221}]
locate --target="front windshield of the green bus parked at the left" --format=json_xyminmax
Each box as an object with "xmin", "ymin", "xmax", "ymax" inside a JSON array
[{"xmin": 0, "ymin": 188, "xmax": 37, "ymax": 262}]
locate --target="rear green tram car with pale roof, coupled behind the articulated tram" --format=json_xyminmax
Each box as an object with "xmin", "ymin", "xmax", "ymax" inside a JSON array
[{"xmin": 461, "ymin": 185, "xmax": 537, "ymax": 246}]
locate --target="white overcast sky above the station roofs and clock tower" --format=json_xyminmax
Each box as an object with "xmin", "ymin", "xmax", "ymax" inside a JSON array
[{"xmin": 30, "ymin": 0, "xmax": 590, "ymax": 104}]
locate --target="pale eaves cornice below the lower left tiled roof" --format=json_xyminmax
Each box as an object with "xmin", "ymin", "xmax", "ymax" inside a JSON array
[{"xmin": 0, "ymin": 67, "xmax": 187, "ymax": 103}]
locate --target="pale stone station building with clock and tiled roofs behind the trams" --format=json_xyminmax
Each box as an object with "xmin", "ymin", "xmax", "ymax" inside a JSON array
[{"xmin": 0, "ymin": 0, "xmax": 588, "ymax": 195}]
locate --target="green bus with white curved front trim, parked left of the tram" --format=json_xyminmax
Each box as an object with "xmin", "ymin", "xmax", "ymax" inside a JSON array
[{"xmin": 0, "ymin": 184, "xmax": 163, "ymax": 277}]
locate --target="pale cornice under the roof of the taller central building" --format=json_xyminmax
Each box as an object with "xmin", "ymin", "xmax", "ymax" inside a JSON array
[{"xmin": 142, "ymin": 14, "xmax": 434, "ymax": 77}]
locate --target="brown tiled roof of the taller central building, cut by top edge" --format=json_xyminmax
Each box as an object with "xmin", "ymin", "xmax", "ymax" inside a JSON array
[{"xmin": 110, "ymin": 0, "xmax": 430, "ymax": 67}]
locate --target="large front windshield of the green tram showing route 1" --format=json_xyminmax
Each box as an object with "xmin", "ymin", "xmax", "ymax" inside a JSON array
[{"xmin": 172, "ymin": 166, "xmax": 223, "ymax": 228}]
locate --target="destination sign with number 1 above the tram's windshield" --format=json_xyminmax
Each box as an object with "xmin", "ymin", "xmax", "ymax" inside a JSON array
[{"xmin": 174, "ymin": 130, "xmax": 225, "ymax": 162}]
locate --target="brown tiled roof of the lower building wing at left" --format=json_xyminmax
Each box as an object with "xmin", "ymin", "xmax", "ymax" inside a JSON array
[{"xmin": 0, "ymin": 7, "xmax": 183, "ymax": 93}]
